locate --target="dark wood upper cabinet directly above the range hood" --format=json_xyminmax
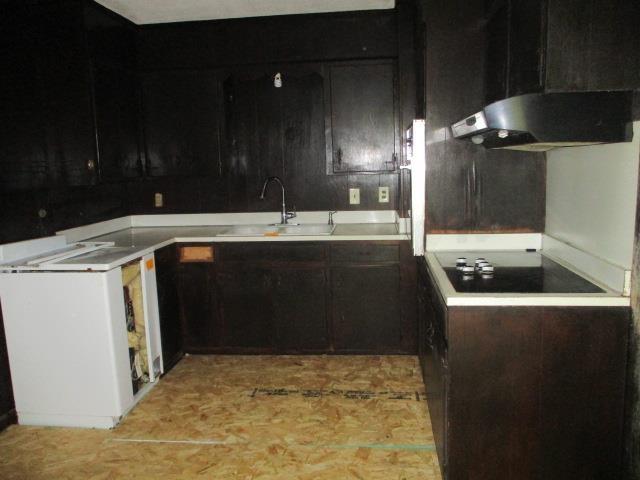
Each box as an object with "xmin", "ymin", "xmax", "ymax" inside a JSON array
[{"xmin": 485, "ymin": 0, "xmax": 640, "ymax": 103}]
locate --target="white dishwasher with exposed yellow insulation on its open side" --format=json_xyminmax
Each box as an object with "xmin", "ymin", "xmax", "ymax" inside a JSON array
[{"xmin": 0, "ymin": 237, "xmax": 163, "ymax": 428}]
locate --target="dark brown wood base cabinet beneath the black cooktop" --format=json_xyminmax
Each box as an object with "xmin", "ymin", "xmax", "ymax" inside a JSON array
[{"xmin": 418, "ymin": 261, "xmax": 630, "ymax": 480}]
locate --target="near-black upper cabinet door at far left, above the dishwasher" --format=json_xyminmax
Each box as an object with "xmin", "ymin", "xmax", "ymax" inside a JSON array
[{"xmin": 0, "ymin": 2, "xmax": 97, "ymax": 191}]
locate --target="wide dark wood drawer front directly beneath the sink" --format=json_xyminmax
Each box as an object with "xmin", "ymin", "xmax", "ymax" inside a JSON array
[{"xmin": 220, "ymin": 242, "xmax": 325, "ymax": 263}]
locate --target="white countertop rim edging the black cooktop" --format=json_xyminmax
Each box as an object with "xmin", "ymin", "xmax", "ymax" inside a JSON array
[{"xmin": 425, "ymin": 252, "xmax": 631, "ymax": 307}]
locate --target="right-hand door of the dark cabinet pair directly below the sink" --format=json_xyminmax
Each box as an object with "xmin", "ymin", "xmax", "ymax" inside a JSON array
[{"xmin": 274, "ymin": 267, "xmax": 329, "ymax": 353}]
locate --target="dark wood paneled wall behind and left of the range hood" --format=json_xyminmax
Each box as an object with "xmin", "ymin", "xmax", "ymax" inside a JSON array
[{"xmin": 420, "ymin": 0, "xmax": 545, "ymax": 233}]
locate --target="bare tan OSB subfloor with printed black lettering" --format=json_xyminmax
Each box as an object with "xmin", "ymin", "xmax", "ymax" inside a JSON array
[{"xmin": 0, "ymin": 356, "xmax": 440, "ymax": 480}]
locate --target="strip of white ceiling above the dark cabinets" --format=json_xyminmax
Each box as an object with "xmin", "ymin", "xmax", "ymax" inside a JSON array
[{"xmin": 96, "ymin": 0, "xmax": 395, "ymax": 24}]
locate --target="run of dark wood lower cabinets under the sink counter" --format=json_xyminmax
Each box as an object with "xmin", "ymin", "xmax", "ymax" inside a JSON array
[{"xmin": 172, "ymin": 242, "xmax": 416, "ymax": 354}]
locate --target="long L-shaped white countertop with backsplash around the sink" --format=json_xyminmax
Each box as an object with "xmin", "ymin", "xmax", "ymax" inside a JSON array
[{"xmin": 0, "ymin": 210, "xmax": 411, "ymax": 272}]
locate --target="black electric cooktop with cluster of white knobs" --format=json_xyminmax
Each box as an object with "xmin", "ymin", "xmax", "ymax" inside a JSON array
[{"xmin": 436, "ymin": 252, "xmax": 605, "ymax": 293}]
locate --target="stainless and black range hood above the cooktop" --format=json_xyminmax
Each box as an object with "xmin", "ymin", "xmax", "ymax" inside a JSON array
[{"xmin": 451, "ymin": 91, "xmax": 633, "ymax": 152}]
